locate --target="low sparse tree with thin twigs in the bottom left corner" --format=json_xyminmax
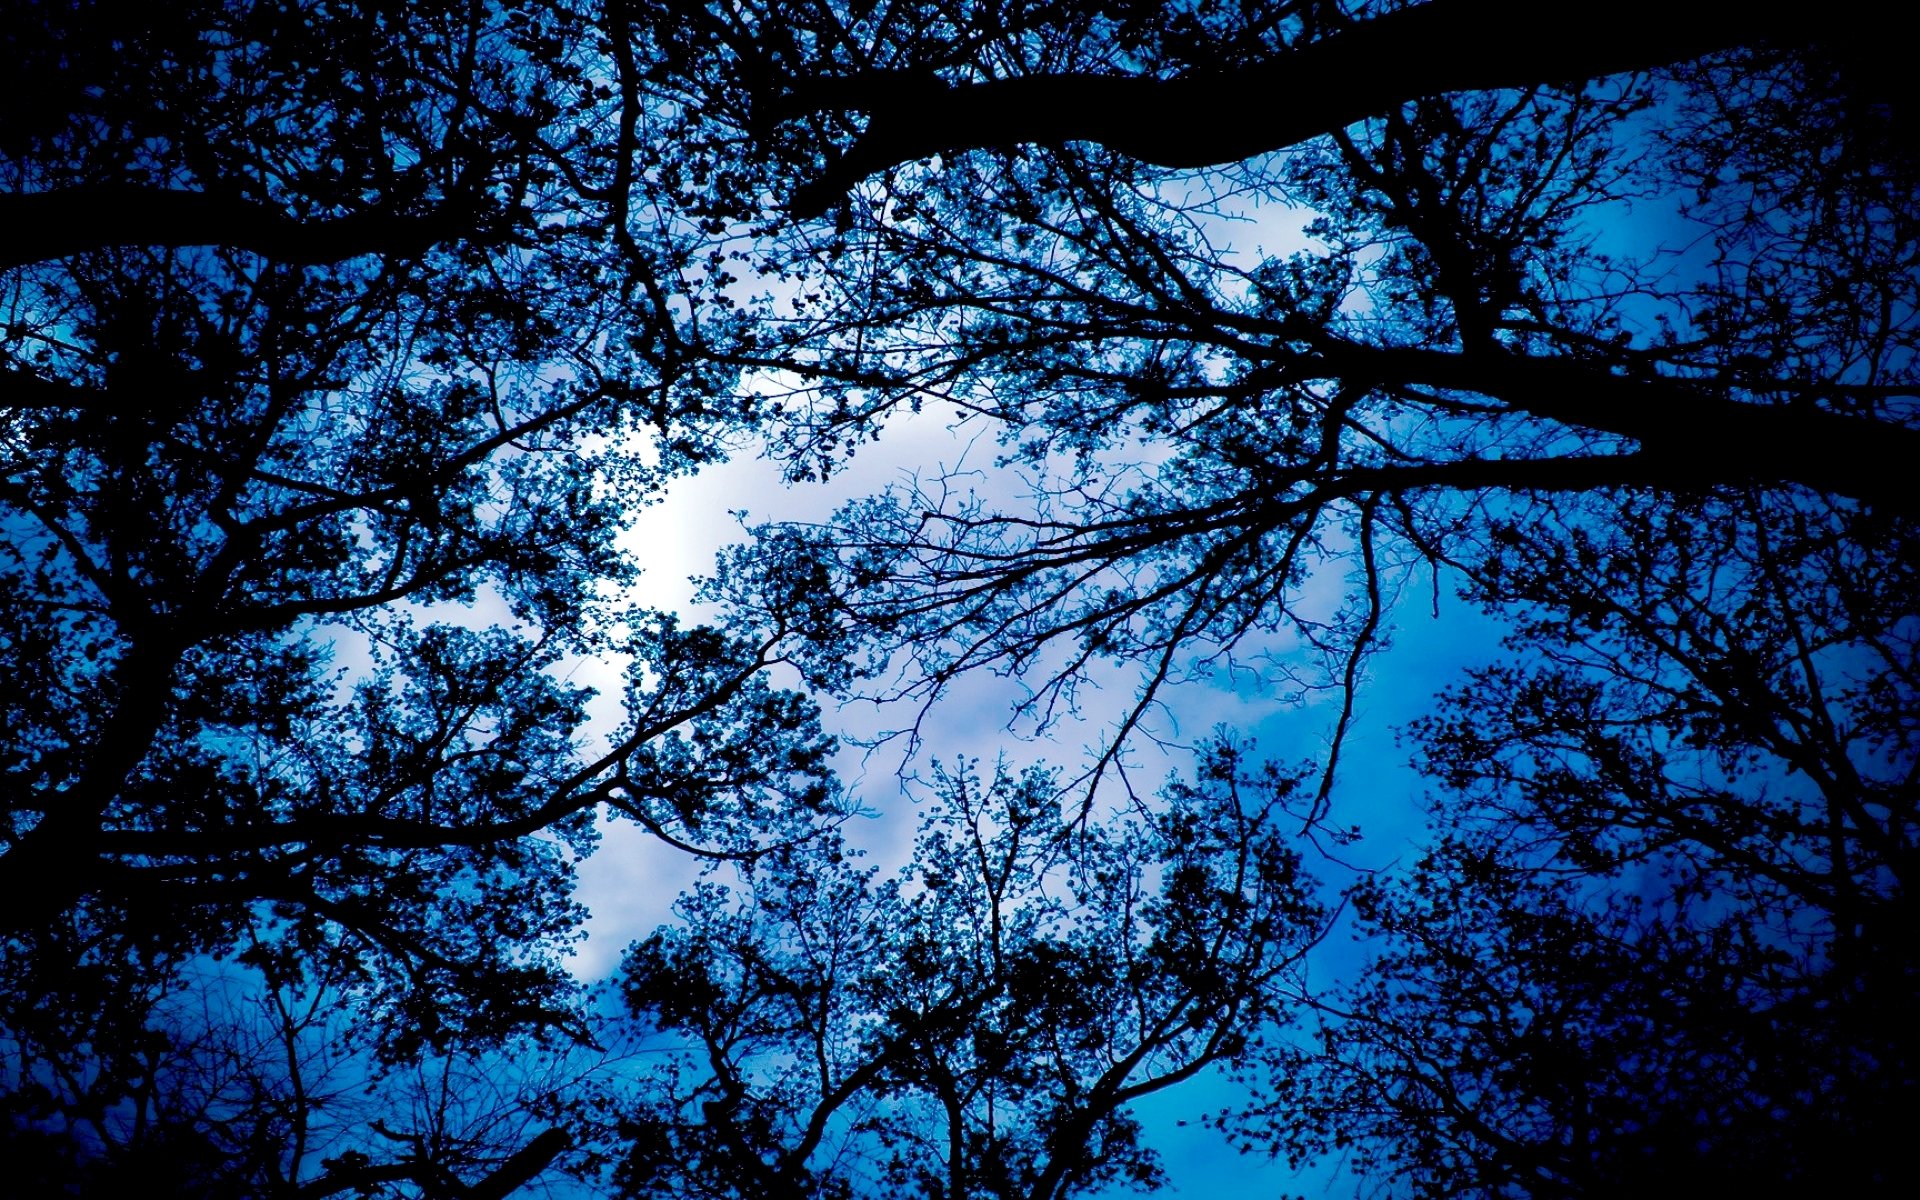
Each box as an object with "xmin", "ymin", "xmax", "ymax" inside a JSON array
[{"xmin": 0, "ymin": 964, "xmax": 595, "ymax": 1198}]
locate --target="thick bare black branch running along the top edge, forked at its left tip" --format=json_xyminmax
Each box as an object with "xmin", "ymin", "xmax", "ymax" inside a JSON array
[{"xmin": 776, "ymin": 0, "xmax": 1776, "ymax": 217}]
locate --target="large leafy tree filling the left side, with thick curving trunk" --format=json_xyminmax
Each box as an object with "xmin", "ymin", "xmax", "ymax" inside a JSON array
[{"xmin": 0, "ymin": 2, "xmax": 833, "ymax": 1194}]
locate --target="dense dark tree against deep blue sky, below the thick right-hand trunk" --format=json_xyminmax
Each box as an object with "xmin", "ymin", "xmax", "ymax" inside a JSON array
[{"xmin": 1205, "ymin": 481, "xmax": 1920, "ymax": 1196}]
